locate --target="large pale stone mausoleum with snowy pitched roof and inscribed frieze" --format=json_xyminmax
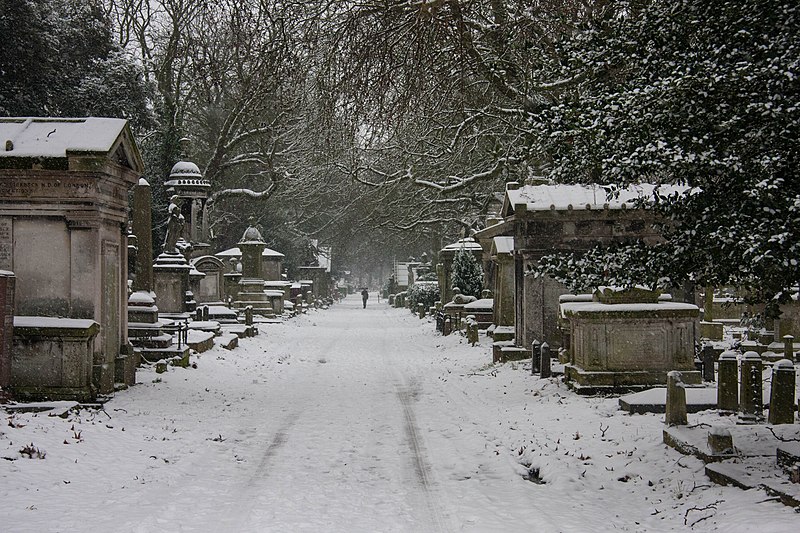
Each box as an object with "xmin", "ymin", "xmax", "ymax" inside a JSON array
[{"xmin": 0, "ymin": 118, "xmax": 144, "ymax": 400}]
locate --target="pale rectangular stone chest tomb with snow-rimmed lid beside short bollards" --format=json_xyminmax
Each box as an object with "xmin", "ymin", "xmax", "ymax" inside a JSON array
[{"xmin": 560, "ymin": 287, "xmax": 700, "ymax": 392}]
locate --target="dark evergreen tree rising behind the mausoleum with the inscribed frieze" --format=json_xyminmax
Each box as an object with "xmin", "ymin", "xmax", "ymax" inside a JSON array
[{"xmin": 0, "ymin": 0, "xmax": 151, "ymax": 130}]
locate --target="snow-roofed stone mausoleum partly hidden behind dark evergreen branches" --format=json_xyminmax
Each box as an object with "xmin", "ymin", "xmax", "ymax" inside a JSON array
[{"xmin": 490, "ymin": 183, "xmax": 676, "ymax": 349}]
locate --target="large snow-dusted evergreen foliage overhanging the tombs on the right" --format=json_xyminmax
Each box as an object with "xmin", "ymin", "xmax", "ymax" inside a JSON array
[{"xmin": 531, "ymin": 0, "xmax": 800, "ymax": 314}]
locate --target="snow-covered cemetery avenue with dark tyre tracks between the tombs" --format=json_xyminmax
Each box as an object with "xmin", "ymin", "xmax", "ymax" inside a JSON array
[{"xmin": 0, "ymin": 293, "xmax": 797, "ymax": 532}]
